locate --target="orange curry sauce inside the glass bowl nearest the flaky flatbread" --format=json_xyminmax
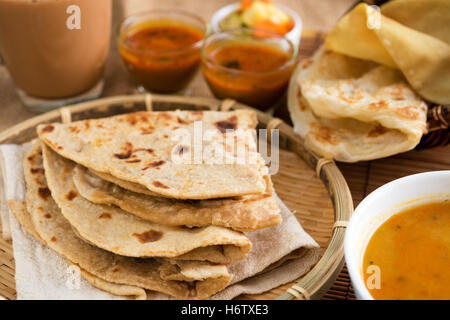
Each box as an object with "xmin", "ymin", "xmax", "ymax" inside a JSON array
[{"xmin": 202, "ymin": 42, "xmax": 293, "ymax": 109}]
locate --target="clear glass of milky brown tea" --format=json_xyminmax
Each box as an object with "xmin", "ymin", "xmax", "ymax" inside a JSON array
[{"xmin": 0, "ymin": 0, "xmax": 112, "ymax": 112}]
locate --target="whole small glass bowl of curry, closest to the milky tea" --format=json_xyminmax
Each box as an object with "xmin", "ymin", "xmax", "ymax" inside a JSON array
[{"xmin": 118, "ymin": 10, "xmax": 207, "ymax": 93}]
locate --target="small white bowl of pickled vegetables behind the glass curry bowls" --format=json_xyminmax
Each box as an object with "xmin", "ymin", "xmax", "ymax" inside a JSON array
[{"xmin": 211, "ymin": 0, "xmax": 302, "ymax": 46}]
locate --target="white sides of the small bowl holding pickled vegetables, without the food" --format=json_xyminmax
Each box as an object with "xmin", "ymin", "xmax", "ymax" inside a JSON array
[{"xmin": 211, "ymin": 3, "xmax": 302, "ymax": 47}]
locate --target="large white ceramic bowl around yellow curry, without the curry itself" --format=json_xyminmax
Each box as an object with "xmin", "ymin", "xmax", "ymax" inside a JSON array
[{"xmin": 344, "ymin": 170, "xmax": 450, "ymax": 300}]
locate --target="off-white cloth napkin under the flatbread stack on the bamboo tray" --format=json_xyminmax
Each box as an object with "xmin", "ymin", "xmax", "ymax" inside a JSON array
[{"xmin": 0, "ymin": 145, "xmax": 320, "ymax": 300}]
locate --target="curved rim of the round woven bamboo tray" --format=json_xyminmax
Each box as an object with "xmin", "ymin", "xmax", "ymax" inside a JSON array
[{"xmin": 0, "ymin": 94, "xmax": 353, "ymax": 300}]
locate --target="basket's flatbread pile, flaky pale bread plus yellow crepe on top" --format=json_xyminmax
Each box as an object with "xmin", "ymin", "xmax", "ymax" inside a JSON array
[{"xmin": 289, "ymin": 0, "xmax": 440, "ymax": 162}]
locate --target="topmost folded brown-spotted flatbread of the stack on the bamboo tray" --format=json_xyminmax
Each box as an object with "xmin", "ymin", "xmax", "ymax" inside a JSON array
[{"xmin": 38, "ymin": 110, "xmax": 268, "ymax": 199}]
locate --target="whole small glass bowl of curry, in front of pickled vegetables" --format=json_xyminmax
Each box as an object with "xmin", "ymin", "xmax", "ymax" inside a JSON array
[{"xmin": 202, "ymin": 28, "xmax": 297, "ymax": 110}]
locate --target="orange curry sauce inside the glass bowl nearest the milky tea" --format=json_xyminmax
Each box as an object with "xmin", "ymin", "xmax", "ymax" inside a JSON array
[{"xmin": 119, "ymin": 20, "xmax": 204, "ymax": 93}]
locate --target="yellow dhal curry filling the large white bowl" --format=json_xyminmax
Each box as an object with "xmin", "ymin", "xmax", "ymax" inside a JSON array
[{"xmin": 363, "ymin": 200, "xmax": 450, "ymax": 300}]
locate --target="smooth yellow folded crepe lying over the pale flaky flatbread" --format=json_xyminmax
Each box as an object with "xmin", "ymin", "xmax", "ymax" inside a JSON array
[{"xmin": 325, "ymin": 0, "xmax": 450, "ymax": 104}]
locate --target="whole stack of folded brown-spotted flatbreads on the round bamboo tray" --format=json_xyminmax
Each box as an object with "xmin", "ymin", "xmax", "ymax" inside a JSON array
[{"xmin": 19, "ymin": 110, "xmax": 281, "ymax": 299}]
